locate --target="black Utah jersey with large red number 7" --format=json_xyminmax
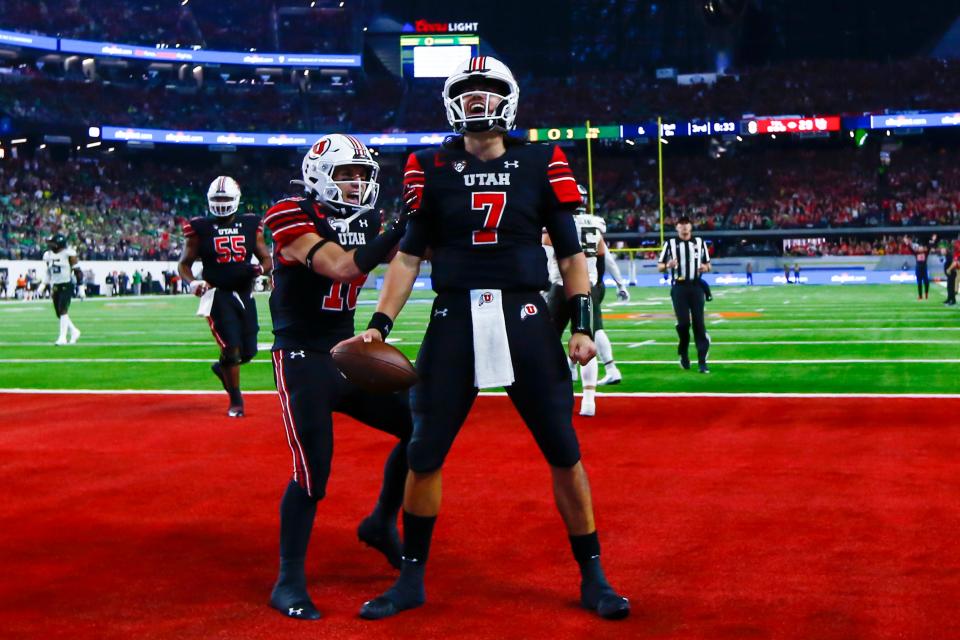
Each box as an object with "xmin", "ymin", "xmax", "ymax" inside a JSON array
[{"xmin": 400, "ymin": 144, "xmax": 580, "ymax": 292}]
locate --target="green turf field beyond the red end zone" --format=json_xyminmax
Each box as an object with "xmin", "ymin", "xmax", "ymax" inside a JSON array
[{"xmin": 0, "ymin": 285, "xmax": 960, "ymax": 393}]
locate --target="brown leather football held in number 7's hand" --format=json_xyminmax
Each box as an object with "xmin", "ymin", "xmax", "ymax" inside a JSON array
[{"xmin": 332, "ymin": 341, "xmax": 419, "ymax": 393}]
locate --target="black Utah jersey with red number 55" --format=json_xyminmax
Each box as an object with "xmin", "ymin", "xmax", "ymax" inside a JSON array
[{"xmin": 183, "ymin": 213, "xmax": 262, "ymax": 293}]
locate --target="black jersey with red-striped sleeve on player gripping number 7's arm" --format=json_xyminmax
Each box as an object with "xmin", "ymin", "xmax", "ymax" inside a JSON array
[{"xmin": 263, "ymin": 198, "xmax": 380, "ymax": 351}]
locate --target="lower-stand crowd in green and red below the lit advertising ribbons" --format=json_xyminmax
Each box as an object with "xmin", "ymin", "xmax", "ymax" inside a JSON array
[{"xmin": 0, "ymin": 147, "xmax": 960, "ymax": 259}]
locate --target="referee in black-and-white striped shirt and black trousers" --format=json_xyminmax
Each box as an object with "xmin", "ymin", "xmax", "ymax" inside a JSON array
[{"xmin": 657, "ymin": 216, "xmax": 710, "ymax": 373}]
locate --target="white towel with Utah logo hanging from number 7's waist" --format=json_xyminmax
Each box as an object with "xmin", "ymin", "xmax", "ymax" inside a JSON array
[{"xmin": 470, "ymin": 289, "xmax": 515, "ymax": 389}]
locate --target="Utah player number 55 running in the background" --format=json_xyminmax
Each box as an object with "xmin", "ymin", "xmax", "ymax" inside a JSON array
[{"xmin": 177, "ymin": 176, "xmax": 273, "ymax": 418}]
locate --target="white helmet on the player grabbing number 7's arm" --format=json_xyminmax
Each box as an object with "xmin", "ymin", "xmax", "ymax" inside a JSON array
[{"xmin": 294, "ymin": 133, "xmax": 380, "ymax": 215}]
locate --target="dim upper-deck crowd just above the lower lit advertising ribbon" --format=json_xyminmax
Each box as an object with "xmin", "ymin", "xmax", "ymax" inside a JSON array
[{"xmin": 0, "ymin": 58, "xmax": 960, "ymax": 132}]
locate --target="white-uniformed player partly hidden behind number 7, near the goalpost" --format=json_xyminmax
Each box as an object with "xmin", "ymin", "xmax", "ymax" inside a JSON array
[{"xmin": 542, "ymin": 185, "xmax": 630, "ymax": 416}]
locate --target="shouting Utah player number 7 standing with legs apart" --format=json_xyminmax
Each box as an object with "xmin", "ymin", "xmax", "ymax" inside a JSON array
[{"xmin": 344, "ymin": 56, "xmax": 630, "ymax": 619}]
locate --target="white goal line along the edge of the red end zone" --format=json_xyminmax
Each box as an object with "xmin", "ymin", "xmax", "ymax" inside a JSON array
[{"xmin": 0, "ymin": 388, "xmax": 960, "ymax": 399}]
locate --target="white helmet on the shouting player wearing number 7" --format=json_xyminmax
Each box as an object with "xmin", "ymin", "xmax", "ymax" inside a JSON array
[{"xmin": 443, "ymin": 56, "xmax": 520, "ymax": 133}]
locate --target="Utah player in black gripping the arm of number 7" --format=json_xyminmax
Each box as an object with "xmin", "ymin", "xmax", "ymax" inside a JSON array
[{"xmin": 263, "ymin": 134, "xmax": 413, "ymax": 620}]
